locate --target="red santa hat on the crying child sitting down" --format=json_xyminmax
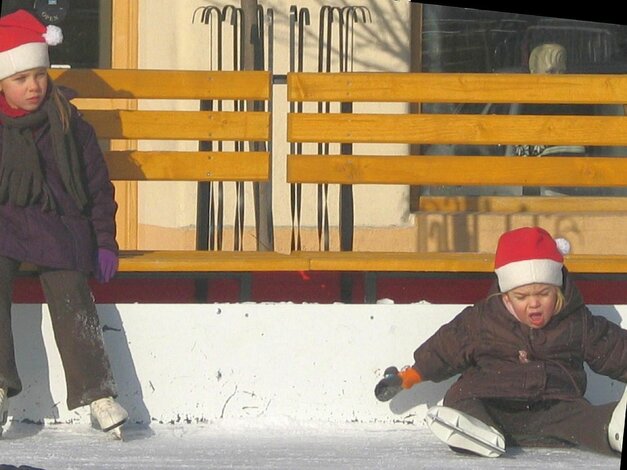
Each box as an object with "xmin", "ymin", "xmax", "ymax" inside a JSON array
[{"xmin": 494, "ymin": 227, "xmax": 570, "ymax": 292}]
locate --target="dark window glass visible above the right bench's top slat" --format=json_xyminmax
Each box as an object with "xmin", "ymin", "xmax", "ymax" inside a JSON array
[{"xmin": 422, "ymin": 4, "xmax": 627, "ymax": 73}]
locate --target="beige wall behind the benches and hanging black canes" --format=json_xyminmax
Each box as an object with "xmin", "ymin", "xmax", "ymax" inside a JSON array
[{"xmin": 139, "ymin": 0, "xmax": 415, "ymax": 251}]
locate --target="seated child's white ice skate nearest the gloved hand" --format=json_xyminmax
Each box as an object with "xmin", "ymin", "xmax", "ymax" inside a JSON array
[{"xmin": 425, "ymin": 406, "xmax": 505, "ymax": 457}]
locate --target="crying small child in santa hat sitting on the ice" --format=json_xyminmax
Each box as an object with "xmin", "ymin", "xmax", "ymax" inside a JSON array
[{"xmin": 375, "ymin": 227, "xmax": 627, "ymax": 457}]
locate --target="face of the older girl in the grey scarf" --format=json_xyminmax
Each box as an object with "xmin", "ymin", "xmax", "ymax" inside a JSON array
[{"xmin": 0, "ymin": 68, "xmax": 48, "ymax": 111}]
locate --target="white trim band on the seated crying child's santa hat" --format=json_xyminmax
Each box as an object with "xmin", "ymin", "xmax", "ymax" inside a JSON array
[{"xmin": 494, "ymin": 259, "xmax": 563, "ymax": 292}]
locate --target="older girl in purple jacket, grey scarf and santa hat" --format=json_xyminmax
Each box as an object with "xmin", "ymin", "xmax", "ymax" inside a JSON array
[{"xmin": 0, "ymin": 10, "xmax": 128, "ymax": 431}]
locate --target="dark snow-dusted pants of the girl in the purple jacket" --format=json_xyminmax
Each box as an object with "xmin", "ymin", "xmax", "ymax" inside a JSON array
[{"xmin": 0, "ymin": 256, "xmax": 116, "ymax": 409}]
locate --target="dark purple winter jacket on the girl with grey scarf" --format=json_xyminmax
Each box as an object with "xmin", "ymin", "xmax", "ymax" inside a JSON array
[{"xmin": 0, "ymin": 94, "xmax": 119, "ymax": 274}]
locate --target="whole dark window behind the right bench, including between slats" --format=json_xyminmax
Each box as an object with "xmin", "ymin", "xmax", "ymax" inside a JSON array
[{"xmin": 411, "ymin": 4, "xmax": 627, "ymax": 201}]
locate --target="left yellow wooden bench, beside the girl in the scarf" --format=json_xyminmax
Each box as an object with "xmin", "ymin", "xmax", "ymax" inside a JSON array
[{"xmin": 44, "ymin": 69, "xmax": 308, "ymax": 275}]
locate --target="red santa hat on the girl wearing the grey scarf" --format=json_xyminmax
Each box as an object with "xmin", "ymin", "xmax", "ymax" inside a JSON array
[{"xmin": 0, "ymin": 10, "xmax": 63, "ymax": 80}]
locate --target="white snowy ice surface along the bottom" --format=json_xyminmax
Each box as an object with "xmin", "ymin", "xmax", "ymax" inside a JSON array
[{"xmin": 0, "ymin": 419, "xmax": 621, "ymax": 470}]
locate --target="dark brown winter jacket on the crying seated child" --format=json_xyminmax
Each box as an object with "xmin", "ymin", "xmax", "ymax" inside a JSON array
[{"xmin": 413, "ymin": 269, "xmax": 627, "ymax": 404}]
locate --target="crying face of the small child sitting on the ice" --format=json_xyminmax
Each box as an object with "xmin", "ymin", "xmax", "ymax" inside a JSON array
[{"xmin": 503, "ymin": 284, "xmax": 557, "ymax": 328}]
